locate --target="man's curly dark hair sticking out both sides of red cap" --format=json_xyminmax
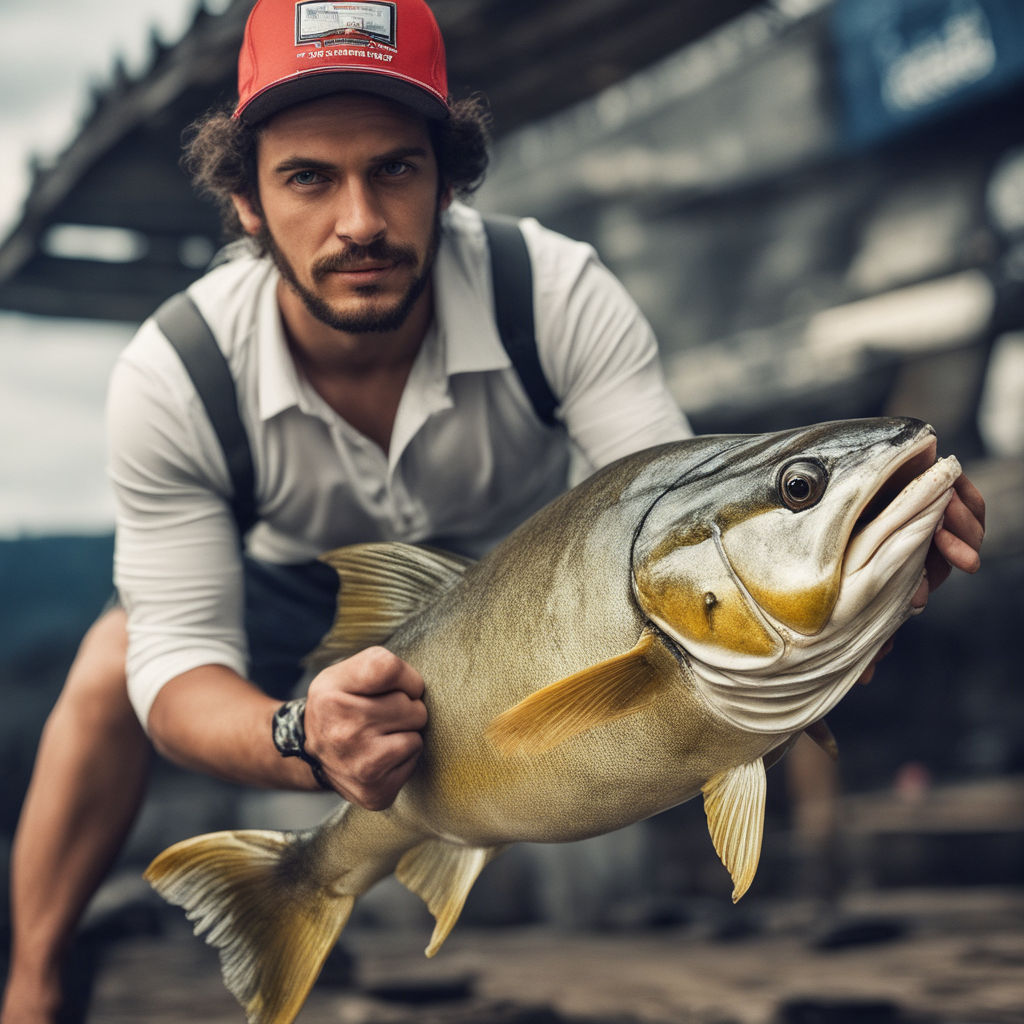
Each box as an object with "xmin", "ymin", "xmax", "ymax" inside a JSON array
[{"xmin": 181, "ymin": 95, "xmax": 490, "ymax": 239}]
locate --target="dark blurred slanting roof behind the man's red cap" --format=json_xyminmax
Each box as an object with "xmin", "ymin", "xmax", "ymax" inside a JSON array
[{"xmin": 0, "ymin": 0, "xmax": 763, "ymax": 321}]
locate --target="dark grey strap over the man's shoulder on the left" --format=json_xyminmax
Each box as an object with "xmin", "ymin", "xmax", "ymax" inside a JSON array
[{"xmin": 154, "ymin": 292, "xmax": 257, "ymax": 539}]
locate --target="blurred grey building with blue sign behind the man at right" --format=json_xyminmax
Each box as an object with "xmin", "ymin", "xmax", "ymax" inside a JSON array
[{"xmin": 480, "ymin": 0, "xmax": 1024, "ymax": 460}]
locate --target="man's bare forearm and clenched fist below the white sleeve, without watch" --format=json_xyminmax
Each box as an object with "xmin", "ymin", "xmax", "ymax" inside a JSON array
[{"xmin": 148, "ymin": 647, "xmax": 427, "ymax": 810}]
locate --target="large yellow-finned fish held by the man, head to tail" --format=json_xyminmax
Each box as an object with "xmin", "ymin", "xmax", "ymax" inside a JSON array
[{"xmin": 146, "ymin": 419, "xmax": 959, "ymax": 1024}]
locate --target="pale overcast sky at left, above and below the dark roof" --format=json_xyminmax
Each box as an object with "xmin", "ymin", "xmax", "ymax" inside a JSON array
[{"xmin": 0, "ymin": 0, "xmax": 225, "ymax": 538}]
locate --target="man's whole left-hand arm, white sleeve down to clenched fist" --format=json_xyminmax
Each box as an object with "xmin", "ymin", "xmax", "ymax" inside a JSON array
[{"xmin": 108, "ymin": 325, "xmax": 426, "ymax": 808}]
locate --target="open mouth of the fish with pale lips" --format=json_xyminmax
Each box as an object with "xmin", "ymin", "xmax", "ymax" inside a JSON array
[{"xmin": 844, "ymin": 434, "xmax": 961, "ymax": 574}]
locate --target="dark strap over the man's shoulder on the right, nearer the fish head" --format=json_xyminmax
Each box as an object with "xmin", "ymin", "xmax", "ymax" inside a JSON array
[{"xmin": 483, "ymin": 216, "xmax": 558, "ymax": 426}]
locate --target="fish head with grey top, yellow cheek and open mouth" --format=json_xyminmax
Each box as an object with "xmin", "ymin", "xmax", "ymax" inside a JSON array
[{"xmin": 632, "ymin": 419, "xmax": 959, "ymax": 732}]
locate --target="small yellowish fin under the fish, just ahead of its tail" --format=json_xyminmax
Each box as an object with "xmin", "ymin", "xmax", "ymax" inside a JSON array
[{"xmin": 394, "ymin": 840, "xmax": 503, "ymax": 956}]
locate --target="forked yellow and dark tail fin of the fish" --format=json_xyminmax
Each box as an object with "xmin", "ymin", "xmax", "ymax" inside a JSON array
[{"xmin": 145, "ymin": 830, "xmax": 355, "ymax": 1024}]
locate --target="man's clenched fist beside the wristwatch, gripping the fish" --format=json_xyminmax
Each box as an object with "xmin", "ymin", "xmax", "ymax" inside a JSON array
[{"xmin": 305, "ymin": 647, "xmax": 427, "ymax": 811}]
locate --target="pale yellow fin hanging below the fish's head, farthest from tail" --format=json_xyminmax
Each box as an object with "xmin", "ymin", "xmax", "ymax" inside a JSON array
[{"xmin": 701, "ymin": 758, "xmax": 766, "ymax": 903}]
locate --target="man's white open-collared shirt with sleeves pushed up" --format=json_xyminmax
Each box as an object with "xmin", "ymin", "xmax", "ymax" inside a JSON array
[{"xmin": 108, "ymin": 204, "xmax": 690, "ymax": 723}]
